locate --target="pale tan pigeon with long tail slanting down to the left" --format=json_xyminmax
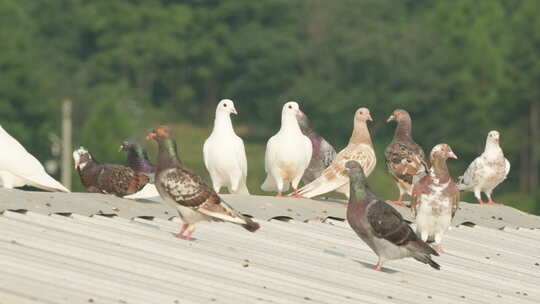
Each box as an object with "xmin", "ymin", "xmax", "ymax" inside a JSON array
[{"xmin": 297, "ymin": 108, "xmax": 377, "ymax": 198}]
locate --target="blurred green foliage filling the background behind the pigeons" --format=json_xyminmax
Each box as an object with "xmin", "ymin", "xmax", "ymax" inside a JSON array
[{"xmin": 0, "ymin": 0, "xmax": 540, "ymax": 213}]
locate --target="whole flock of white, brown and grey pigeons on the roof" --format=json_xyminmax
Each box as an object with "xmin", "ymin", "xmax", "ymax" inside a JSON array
[{"xmin": 0, "ymin": 99, "xmax": 510, "ymax": 270}]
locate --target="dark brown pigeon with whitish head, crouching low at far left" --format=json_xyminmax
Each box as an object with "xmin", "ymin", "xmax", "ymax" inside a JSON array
[{"xmin": 73, "ymin": 147, "xmax": 149, "ymax": 197}]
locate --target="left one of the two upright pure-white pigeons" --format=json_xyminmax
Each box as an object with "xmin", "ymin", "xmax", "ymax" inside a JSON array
[{"xmin": 203, "ymin": 99, "xmax": 249, "ymax": 195}]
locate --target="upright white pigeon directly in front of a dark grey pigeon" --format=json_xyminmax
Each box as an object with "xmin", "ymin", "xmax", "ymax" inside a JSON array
[{"xmin": 261, "ymin": 101, "xmax": 313, "ymax": 196}]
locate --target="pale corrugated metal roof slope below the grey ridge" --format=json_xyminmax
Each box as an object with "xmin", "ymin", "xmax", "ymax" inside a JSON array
[{"xmin": 0, "ymin": 193, "xmax": 540, "ymax": 303}]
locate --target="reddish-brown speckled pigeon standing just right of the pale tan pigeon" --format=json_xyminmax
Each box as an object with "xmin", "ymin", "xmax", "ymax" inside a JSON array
[{"xmin": 384, "ymin": 109, "xmax": 428, "ymax": 205}]
